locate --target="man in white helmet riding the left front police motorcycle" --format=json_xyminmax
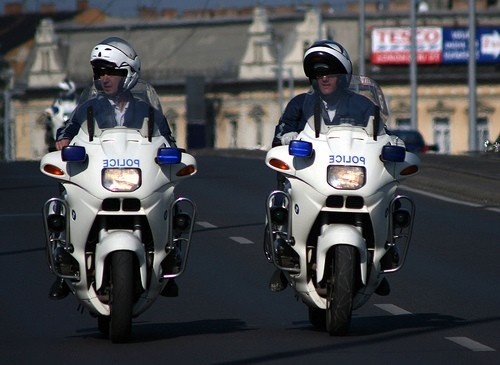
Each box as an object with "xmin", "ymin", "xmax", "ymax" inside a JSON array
[{"xmin": 49, "ymin": 37, "xmax": 178, "ymax": 299}]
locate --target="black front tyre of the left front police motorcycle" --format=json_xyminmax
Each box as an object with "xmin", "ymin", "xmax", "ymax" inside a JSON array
[{"xmin": 109, "ymin": 251, "xmax": 134, "ymax": 343}]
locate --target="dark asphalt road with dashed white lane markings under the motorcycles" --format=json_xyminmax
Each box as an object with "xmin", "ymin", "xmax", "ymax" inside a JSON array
[{"xmin": 0, "ymin": 151, "xmax": 500, "ymax": 365}]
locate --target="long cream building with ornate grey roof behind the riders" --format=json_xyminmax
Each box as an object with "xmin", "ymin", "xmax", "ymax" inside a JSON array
[{"xmin": 3, "ymin": 1, "xmax": 500, "ymax": 159}]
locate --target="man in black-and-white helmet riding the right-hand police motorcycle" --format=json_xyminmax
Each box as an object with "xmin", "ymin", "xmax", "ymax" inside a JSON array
[{"xmin": 269, "ymin": 40, "xmax": 390, "ymax": 295}]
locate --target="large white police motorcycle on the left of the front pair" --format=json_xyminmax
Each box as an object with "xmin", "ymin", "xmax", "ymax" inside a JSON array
[{"xmin": 40, "ymin": 82, "xmax": 197, "ymax": 342}]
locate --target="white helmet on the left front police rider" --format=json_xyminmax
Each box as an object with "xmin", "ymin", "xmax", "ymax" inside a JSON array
[{"xmin": 90, "ymin": 37, "xmax": 141, "ymax": 90}]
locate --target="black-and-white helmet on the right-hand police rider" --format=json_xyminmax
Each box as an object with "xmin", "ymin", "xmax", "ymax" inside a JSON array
[{"xmin": 303, "ymin": 40, "xmax": 352, "ymax": 82}]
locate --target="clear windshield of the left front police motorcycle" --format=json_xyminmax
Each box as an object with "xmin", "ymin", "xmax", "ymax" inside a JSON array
[{"xmin": 75, "ymin": 80, "xmax": 166, "ymax": 137}]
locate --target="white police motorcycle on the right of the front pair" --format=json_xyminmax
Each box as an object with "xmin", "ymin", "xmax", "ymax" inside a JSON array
[{"xmin": 264, "ymin": 75, "xmax": 420, "ymax": 336}]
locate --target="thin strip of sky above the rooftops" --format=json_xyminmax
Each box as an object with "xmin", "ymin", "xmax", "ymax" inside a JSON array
[{"xmin": 0, "ymin": 0, "xmax": 340, "ymax": 17}]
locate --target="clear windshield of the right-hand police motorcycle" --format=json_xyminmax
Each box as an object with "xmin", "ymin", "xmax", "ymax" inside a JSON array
[{"xmin": 303, "ymin": 74, "xmax": 389, "ymax": 135}]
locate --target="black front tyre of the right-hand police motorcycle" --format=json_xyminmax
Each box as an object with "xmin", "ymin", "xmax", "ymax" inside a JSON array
[{"xmin": 326, "ymin": 245, "xmax": 358, "ymax": 336}]
